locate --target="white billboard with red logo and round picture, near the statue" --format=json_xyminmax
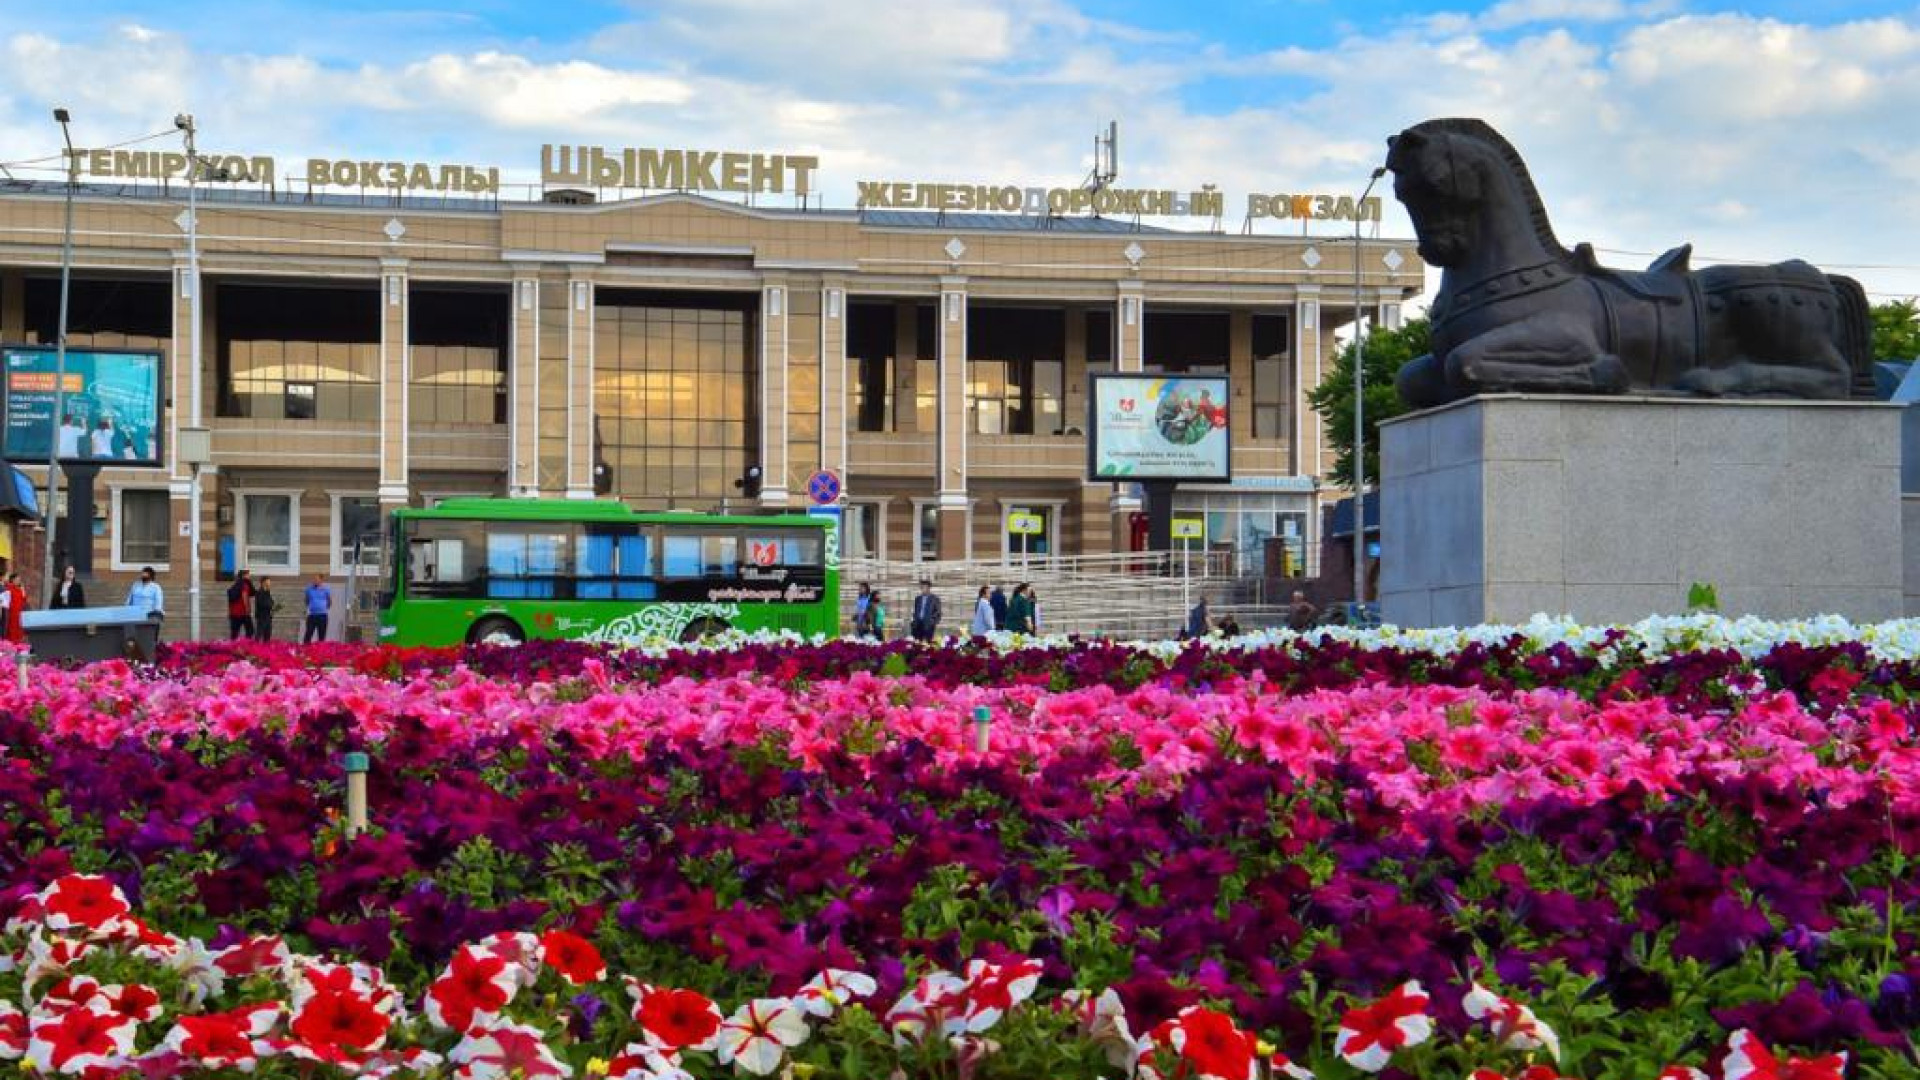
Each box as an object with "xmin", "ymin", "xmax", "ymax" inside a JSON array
[{"xmin": 1087, "ymin": 375, "xmax": 1233, "ymax": 482}]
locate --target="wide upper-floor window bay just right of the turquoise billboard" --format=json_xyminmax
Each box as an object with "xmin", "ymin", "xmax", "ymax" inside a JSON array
[{"xmin": 217, "ymin": 284, "xmax": 380, "ymax": 421}]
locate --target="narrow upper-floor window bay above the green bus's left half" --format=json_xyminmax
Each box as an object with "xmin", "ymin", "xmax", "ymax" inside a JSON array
[{"xmin": 407, "ymin": 288, "xmax": 509, "ymax": 425}]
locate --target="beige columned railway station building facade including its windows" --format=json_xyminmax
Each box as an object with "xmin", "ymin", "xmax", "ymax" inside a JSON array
[{"xmin": 0, "ymin": 164, "xmax": 1423, "ymax": 626}]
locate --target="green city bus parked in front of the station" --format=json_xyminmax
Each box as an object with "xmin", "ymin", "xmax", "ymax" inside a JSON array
[{"xmin": 380, "ymin": 498, "xmax": 839, "ymax": 646}]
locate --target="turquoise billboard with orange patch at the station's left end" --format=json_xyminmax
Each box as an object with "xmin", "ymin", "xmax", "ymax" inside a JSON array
[{"xmin": 0, "ymin": 346, "xmax": 161, "ymax": 465}]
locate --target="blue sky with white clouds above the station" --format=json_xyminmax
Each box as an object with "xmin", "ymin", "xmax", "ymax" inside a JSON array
[{"xmin": 0, "ymin": 0, "xmax": 1920, "ymax": 300}]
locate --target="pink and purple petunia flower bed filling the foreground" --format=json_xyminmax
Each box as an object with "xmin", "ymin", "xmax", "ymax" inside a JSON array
[{"xmin": 0, "ymin": 623, "xmax": 1920, "ymax": 1080}]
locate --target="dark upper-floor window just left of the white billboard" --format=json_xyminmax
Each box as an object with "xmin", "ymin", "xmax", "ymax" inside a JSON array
[{"xmin": 968, "ymin": 307, "xmax": 1066, "ymax": 434}]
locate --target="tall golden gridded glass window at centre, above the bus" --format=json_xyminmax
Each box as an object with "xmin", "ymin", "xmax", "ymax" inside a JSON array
[{"xmin": 593, "ymin": 290, "xmax": 752, "ymax": 507}]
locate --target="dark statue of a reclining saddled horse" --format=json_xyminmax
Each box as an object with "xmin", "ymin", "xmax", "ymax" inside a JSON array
[{"xmin": 1386, "ymin": 119, "xmax": 1872, "ymax": 407}]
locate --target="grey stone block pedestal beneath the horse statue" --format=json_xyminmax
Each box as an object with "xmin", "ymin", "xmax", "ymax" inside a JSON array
[{"xmin": 1380, "ymin": 394, "xmax": 1905, "ymax": 626}]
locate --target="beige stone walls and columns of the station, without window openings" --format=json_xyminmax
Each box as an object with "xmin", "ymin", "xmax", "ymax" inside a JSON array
[{"xmin": 0, "ymin": 188, "xmax": 1423, "ymax": 611}]
